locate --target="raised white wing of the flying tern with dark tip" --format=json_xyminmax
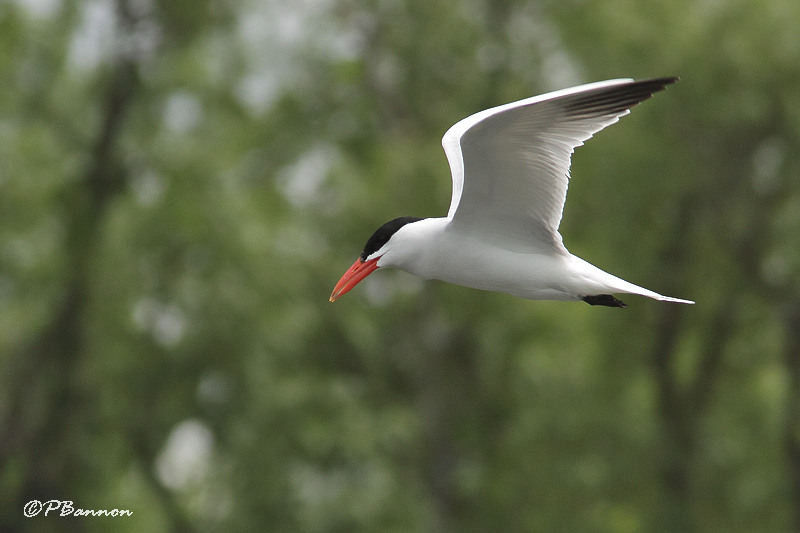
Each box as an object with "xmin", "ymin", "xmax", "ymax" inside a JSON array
[{"xmin": 442, "ymin": 78, "xmax": 678, "ymax": 252}]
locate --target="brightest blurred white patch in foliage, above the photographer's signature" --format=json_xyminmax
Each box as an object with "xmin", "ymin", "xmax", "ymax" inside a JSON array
[{"xmin": 155, "ymin": 419, "xmax": 214, "ymax": 490}]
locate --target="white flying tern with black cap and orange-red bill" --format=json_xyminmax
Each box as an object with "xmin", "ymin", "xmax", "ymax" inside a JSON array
[{"xmin": 330, "ymin": 78, "xmax": 694, "ymax": 307}]
